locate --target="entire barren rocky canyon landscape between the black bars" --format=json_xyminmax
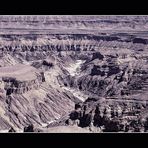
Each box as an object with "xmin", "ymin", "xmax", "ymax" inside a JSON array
[{"xmin": 0, "ymin": 15, "xmax": 148, "ymax": 133}]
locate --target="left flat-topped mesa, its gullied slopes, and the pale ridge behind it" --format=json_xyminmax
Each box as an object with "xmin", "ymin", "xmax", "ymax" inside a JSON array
[{"xmin": 0, "ymin": 40, "xmax": 79, "ymax": 131}]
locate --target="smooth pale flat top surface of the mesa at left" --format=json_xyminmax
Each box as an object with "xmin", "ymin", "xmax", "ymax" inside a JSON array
[{"xmin": 0, "ymin": 64, "xmax": 37, "ymax": 81}]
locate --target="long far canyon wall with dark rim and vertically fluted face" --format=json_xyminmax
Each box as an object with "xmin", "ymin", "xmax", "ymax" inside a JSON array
[{"xmin": 0, "ymin": 33, "xmax": 148, "ymax": 54}]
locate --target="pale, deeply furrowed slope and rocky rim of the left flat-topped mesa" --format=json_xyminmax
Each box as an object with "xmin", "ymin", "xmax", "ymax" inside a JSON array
[{"xmin": 0, "ymin": 62, "xmax": 79, "ymax": 130}]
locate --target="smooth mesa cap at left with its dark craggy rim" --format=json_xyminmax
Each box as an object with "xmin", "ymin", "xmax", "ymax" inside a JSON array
[{"xmin": 0, "ymin": 64, "xmax": 45, "ymax": 95}]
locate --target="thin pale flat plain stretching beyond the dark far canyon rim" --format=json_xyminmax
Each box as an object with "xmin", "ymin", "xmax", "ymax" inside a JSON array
[{"xmin": 0, "ymin": 27, "xmax": 148, "ymax": 36}]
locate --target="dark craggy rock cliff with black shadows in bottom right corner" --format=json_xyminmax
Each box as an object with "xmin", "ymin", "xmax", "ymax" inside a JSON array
[{"xmin": 64, "ymin": 98, "xmax": 148, "ymax": 132}]
